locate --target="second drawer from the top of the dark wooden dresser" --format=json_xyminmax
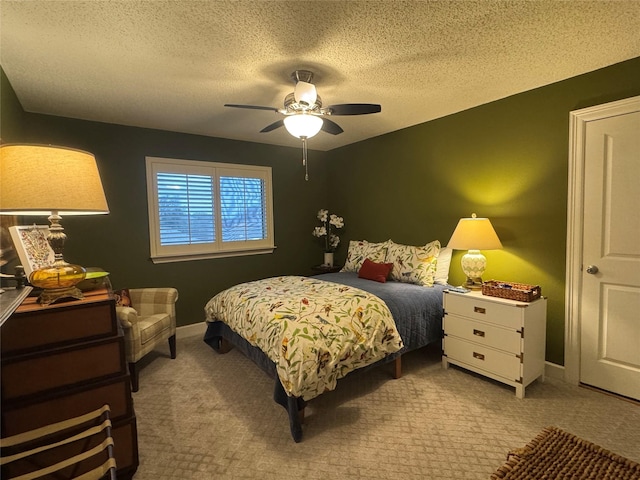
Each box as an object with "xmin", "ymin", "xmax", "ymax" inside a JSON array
[{"xmin": 2, "ymin": 337, "xmax": 127, "ymax": 402}]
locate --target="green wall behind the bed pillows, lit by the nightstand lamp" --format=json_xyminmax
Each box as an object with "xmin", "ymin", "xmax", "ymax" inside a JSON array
[{"xmin": 329, "ymin": 58, "xmax": 640, "ymax": 364}]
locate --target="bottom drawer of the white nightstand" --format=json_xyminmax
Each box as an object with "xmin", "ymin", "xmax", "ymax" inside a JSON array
[{"xmin": 442, "ymin": 337, "xmax": 522, "ymax": 381}]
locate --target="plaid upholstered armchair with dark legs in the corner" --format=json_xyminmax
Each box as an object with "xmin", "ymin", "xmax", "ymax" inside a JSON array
[{"xmin": 116, "ymin": 288, "xmax": 178, "ymax": 392}]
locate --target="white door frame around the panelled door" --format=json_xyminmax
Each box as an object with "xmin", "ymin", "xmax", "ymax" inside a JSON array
[{"xmin": 564, "ymin": 96, "xmax": 640, "ymax": 385}]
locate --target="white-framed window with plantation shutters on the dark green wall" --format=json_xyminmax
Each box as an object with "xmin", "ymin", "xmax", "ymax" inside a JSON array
[{"xmin": 146, "ymin": 157, "xmax": 274, "ymax": 263}]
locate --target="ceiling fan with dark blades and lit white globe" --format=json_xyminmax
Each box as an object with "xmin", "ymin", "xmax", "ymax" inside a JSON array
[{"xmin": 224, "ymin": 70, "xmax": 382, "ymax": 180}]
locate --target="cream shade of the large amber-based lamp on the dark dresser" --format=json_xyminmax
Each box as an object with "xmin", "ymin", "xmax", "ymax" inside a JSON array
[{"xmin": 0, "ymin": 144, "xmax": 109, "ymax": 216}]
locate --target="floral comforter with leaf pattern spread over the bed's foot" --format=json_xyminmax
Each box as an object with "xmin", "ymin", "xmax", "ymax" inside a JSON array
[{"xmin": 205, "ymin": 276, "xmax": 403, "ymax": 400}]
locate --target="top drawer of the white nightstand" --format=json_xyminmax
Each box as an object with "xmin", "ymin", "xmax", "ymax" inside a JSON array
[{"xmin": 444, "ymin": 294, "xmax": 522, "ymax": 330}]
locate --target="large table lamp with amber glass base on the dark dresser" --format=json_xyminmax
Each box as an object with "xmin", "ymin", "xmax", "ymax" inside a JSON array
[{"xmin": 0, "ymin": 144, "xmax": 109, "ymax": 305}]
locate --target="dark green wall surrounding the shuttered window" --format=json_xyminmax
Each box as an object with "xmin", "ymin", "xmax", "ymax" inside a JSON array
[{"xmin": 2, "ymin": 68, "xmax": 327, "ymax": 325}]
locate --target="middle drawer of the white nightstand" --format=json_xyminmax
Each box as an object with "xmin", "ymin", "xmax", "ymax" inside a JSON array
[{"xmin": 443, "ymin": 313, "xmax": 522, "ymax": 354}]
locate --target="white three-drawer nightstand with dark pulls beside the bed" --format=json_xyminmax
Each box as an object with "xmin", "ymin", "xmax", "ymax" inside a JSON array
[{"xmin": 442, "ymin": 291, "xmax": 547, "ymax": 398}]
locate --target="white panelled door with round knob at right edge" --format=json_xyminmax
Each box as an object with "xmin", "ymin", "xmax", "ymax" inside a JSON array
[{"xmin": 579, "ymin": 95, "xmax": 640, "ymax": 400}]
